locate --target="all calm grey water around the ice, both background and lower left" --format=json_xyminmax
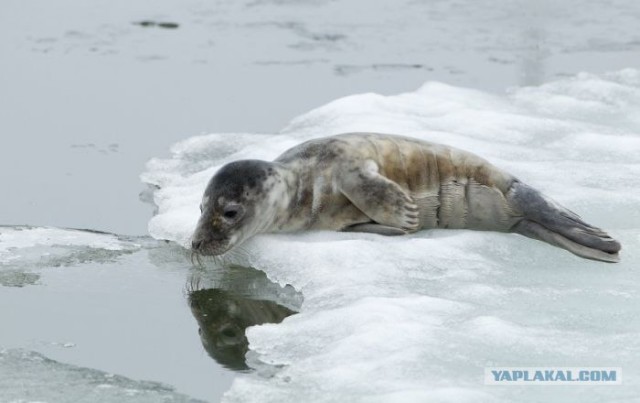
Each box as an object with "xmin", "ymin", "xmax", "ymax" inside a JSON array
[{"xmin": 0, "ymin": 0, "xmax": 640, "ymax": 401}]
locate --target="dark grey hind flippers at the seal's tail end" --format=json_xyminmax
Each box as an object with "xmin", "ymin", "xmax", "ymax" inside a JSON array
[{"xmin": 507, "ymin": 181, "xmax": 620, "ymax": 263}]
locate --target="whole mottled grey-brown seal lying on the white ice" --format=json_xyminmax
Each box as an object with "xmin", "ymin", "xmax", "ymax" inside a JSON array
[{"xmin": 192, "ymin": 133, "xmax": 620, "ymax": 262}]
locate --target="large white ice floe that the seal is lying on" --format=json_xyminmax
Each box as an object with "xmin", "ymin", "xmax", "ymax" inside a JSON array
[{"xmin": 142, "ymin": 69, "xmax": 640, "ymax": 402}]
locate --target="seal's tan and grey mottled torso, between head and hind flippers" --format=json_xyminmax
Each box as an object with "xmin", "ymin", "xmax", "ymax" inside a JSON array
[{"xmin": 276, "ymin": 134, "xmax": 518, "ymax": 232}]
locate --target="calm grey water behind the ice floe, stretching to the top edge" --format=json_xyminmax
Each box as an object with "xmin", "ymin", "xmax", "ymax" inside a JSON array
[{"xmin": 0, "ymin": 0, "xmax": 640, "ymax": 235}]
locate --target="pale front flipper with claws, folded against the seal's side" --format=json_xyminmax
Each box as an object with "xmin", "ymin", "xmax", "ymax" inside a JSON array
[{"xmin": 336, "ymin": 160, "xmax": 419, "ymax": 233}]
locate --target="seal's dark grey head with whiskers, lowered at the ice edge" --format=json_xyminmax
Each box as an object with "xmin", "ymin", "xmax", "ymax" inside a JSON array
[{"xmin": 192, "ymin": 160, "xmax": 283, "ymax": 255}]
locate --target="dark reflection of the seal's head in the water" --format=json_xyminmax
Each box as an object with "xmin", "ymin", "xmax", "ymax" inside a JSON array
[{"xmin": 189, "ymin": 267, "xmax": 299, "ymax": 371}]
